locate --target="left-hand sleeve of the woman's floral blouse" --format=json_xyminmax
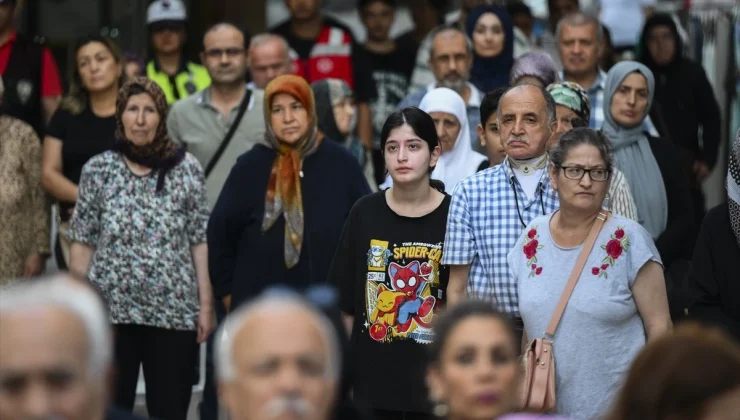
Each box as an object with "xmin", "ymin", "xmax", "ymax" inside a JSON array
[{"xmin": 67, "ymin": 159, "xmax": 106, "ymax": 246}]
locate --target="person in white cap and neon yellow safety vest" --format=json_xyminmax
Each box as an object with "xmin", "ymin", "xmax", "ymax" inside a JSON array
[{"xmin": 146, "ymin": 0, "xmax": 211, "ymax": 105}]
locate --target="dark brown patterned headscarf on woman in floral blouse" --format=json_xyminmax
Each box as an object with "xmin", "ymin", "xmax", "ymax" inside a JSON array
[{"xmin": 113, "ymin": 77, "xmax": 185, "ymax": 191}]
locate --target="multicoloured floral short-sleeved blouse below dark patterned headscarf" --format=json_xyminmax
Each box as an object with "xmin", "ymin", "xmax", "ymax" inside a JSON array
[{"xmin": 68, "ymin": 151, "xmax": 209, "ymax": 330}]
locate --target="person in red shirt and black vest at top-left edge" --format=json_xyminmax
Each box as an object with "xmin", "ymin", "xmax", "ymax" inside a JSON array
[{"xmin": 0, "ymin": 0, "xmax": 62, "ymax": 138}]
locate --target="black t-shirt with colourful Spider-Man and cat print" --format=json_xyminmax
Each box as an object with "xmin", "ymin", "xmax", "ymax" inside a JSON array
[{"xmin": 329, "ymin": 191, "xmax": 451, "ymax": 412}]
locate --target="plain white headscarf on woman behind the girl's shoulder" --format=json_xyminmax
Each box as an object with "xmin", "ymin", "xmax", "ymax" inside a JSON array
[{"xmin": 419, "ymin": 88, "xmax": 486, "ymax": 193}]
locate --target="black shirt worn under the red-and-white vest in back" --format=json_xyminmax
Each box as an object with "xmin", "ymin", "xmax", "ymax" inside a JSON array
[{"xmin": 271, "ymin": 16, "xmax": 375, "ymax": 103}]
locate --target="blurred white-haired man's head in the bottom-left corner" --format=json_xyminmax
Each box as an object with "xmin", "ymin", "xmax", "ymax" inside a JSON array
[{"xmin": 0, "ymin": 276, "xmax": 130, "ymax": 420}]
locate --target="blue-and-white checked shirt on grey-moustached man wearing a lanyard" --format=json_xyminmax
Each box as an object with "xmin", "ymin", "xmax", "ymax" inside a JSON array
[{"xmin": 442, "ymin": 159, "xmax": 559, "ymax": 317}]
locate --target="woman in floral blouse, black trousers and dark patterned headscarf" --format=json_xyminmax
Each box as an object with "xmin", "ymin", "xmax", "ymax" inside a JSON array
[{"xmin": 68, "ymin": 78, "xmax": 214, "ymax": 420}]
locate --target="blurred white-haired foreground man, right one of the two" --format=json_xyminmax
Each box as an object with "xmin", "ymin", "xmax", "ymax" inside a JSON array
[{"xmin": 216, "ymin": 296, "xmax": 341, "ymax": 420}]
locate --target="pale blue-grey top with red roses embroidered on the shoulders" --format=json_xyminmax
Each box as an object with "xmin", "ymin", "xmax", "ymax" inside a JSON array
[{"xmin": 508, "ymin": 213, "xmax": 661, "ymax": 420}]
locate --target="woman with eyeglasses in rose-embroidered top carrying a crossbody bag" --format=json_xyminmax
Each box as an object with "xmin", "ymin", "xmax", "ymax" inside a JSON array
[{"xmin": 508, "ymin": 128, "xmax": 671, "ymax": 420}]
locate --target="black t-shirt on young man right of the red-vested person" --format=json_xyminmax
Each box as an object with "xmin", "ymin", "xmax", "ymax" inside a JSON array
[{"xmin": 361, "ymin": 44, "xmax": 416, "ymax": 149}]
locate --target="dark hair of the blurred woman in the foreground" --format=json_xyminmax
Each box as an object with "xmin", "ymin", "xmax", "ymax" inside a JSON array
[{"xmin": 428, "ymin": 299, "xmax": 520, "ymax": 365}]
